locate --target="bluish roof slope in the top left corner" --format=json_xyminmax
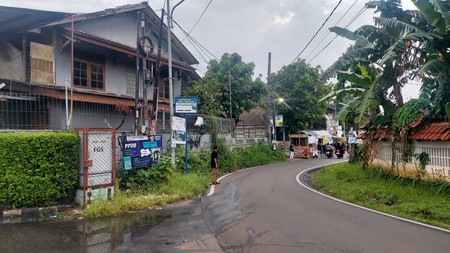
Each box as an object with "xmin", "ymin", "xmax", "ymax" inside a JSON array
[{"xmin": 0, "ymin": 6, "xmax": 69, "ymax": 32}]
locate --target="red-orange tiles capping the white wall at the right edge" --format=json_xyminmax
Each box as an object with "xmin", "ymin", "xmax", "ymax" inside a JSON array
[{"xmin": 411, "ymin": 122, "xmax": 450, "ymax": 141}]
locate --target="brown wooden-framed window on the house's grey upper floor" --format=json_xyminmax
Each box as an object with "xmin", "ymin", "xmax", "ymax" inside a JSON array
[{"xmin": 73, "ymin": 60, "xmax": 105, "ymax": 90}]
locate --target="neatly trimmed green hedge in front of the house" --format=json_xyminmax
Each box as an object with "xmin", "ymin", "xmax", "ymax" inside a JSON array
[{"xmin": 0, "ymin": 132, "xmax": 79, "ymax": 208}]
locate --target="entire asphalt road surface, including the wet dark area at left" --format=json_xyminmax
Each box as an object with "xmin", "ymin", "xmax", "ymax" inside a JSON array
[{"xmin": 0, "ymin": 158, "xmax": 450, "ymax": 253}]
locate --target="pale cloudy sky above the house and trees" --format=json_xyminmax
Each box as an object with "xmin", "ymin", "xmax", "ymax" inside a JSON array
[{"xmin": 0, "ymin": 0, "xmax": 419, "ymax": 99}]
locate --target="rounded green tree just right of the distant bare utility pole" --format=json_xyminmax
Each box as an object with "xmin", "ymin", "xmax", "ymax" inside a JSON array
[{"xmin": 271, "ymin": 60, "xmax": 329, "ymax": 132}]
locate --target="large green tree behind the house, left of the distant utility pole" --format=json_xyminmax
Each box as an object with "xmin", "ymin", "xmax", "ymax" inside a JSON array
[{"xmin": 183, "ymin": 53, "xmax": 266, "ymax": 122}]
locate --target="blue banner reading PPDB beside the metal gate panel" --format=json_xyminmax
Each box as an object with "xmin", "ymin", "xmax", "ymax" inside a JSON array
[{"xmin": 122, "ymin": 135, "xmax": 162, "ymax": 170}]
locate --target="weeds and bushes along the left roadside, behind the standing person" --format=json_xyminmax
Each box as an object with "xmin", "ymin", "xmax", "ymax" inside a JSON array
[{"xmin": 83, "ymin": 139, "xmax": 286, "ymax": 218}]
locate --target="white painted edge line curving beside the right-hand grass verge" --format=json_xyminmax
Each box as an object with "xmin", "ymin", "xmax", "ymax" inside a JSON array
[{"xmin": 296, "ymin": 164, "xmax": 450, "ymax": 233}]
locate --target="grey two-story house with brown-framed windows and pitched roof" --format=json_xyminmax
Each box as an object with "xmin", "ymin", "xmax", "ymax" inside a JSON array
[{"xmin": 0, "ymin": 2, "xmax": 199, "ymax": 132}]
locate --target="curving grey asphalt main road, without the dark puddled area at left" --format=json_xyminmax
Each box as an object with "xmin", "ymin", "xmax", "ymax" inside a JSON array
[{"xmin": 202, "ymin": 158, "xmax": 450, "ymax": 253}]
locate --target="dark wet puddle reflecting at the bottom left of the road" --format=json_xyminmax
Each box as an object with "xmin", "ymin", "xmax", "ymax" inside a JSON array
[{"xmin": 0, "ymin": 210, "xmax": 174, "ymax": 253}]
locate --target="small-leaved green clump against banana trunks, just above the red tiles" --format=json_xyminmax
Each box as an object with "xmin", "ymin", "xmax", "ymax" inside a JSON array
[{"xmin": 392, "ymin": 99, "xmax": 430, "ymax": 132}]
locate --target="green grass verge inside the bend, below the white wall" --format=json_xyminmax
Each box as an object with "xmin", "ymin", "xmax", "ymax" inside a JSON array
[{"xmin": 312, "ymin": 163, "xmax": 450, "ymax": 229}]
